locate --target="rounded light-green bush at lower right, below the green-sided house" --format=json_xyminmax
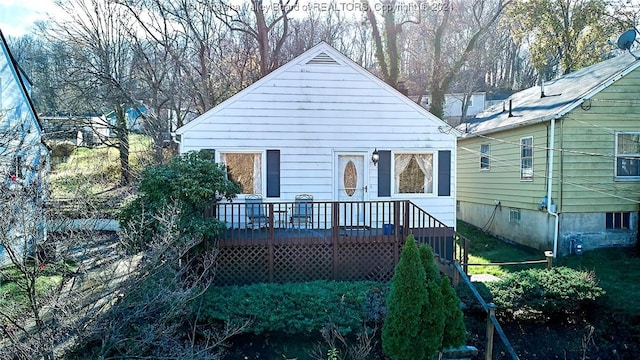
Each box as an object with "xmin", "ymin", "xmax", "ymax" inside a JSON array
[{"xmin": 487, "ymin": 267, "xmax": 605, "ymax": 319}]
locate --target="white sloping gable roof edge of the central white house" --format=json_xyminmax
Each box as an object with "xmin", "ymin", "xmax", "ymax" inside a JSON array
[{"xmin": 176, "ymin": 42, "xmax": 460, "ymax": 136}]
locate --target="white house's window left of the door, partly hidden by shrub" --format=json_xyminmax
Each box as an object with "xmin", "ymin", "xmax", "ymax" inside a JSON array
[{"xmin": 220, "ymin": 153, "xmax": 262, "ymax": 194}]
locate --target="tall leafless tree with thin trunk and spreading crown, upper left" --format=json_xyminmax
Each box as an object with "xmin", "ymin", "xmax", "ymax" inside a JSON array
[{"xmin": 47, "ymin": 0, "xmax": 140, "ymax": 185}]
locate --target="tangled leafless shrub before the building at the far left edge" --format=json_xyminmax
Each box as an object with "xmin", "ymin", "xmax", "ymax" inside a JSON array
[{"xmin": 0, "ymin": 131, "xmax": 56, "ymax": 359}]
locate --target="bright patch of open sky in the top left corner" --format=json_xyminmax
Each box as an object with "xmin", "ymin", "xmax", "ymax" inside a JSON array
[{"xmin": 0, "ymin": 0, "xmax": 56, "ymax": 37}]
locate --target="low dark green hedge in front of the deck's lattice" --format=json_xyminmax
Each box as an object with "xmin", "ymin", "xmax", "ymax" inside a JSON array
[{"xmin": 194, "ymin": 281, "xmax": 386, "ymax": 334}]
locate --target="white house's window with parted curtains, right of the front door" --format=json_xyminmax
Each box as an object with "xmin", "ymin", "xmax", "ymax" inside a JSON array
[{"xmin": 394, "ymin": 154, "xmax": 433, "ymax": 194}]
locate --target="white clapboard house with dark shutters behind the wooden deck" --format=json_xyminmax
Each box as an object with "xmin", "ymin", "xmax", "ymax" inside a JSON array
[{"xmin": 176, "ymin": 43, "xmax": 459, "ymax": 227}]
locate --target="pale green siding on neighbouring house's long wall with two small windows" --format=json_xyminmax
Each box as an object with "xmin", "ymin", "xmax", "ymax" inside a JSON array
[{"xmin": 458, "ymin": 122, "xmax": 558, "ymax": 210}]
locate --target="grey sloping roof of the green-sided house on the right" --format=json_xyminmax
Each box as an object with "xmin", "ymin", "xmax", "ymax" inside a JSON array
[{"xmin": 457, "ymin": 53, "xmax": 640, "ymax": 136}]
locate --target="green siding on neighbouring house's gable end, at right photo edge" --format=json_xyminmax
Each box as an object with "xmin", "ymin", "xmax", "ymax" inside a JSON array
[{"xmin": 561, "ymin": 70, "xmax": 640, "ymax": 212}]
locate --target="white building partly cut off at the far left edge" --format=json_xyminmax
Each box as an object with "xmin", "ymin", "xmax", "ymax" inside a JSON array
[{"xmin": 0, "ymin": 31, "xmax": 49, "ymax": 265}]
